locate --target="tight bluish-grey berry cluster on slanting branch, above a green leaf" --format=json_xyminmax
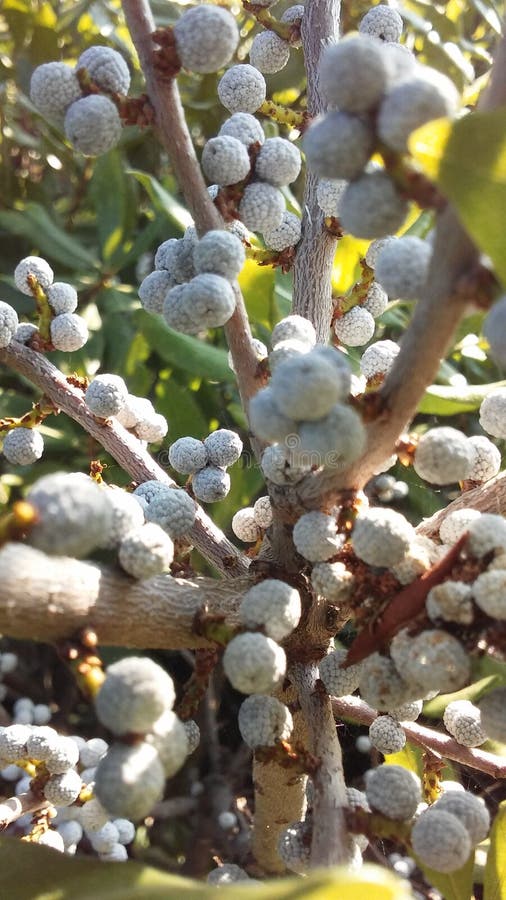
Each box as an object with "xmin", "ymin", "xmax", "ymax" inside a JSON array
[{"xmin": 139, "ymin": 227, "xmax": 246, "ymax": 334}]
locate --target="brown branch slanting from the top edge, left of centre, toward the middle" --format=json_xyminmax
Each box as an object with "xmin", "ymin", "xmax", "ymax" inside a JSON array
[{"xmin": 123, "ymin": 0, "xmax": 259, "ymax": 410}]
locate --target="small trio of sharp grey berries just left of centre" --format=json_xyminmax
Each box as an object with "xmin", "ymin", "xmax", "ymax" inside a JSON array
[{"xmin": 169, "ymin": 428, "xmax": 242, "ymax": 503}]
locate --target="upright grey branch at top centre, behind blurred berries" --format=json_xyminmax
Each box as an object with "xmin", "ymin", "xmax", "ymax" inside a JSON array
[{"xmin": 293, "ymin": 0, "xmax": 341, "ymax": 344}]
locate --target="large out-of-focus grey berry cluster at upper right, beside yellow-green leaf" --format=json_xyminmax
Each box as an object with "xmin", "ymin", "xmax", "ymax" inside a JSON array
[{"xmin": 304, "ymin": 5, "xmax": 458, "ymax": 238}]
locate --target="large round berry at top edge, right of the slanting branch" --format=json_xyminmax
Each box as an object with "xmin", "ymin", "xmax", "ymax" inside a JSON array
[{"xmin": 174, "ymin": 5, "xmax": 239, "ymax": 74}]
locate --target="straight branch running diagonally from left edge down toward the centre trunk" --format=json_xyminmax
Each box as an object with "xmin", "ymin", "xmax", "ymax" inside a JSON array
[{"xmin": 0, "ymin": 341, "xmax": 249, "ymax": 578}]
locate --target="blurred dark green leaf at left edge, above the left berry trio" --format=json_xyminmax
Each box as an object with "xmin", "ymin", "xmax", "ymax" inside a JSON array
[{"xmin": 0, "ymin": 203, "xmax": 98, "ymax": 269}]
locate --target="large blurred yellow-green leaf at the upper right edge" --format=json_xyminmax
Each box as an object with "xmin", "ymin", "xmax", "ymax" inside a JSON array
[{"xmin": 409, "ymin": 107, "xmax": 506, "ymax": 284}]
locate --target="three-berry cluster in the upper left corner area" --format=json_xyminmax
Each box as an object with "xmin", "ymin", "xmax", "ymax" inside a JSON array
[{"xmin": 30, "ymin": 46, "xmax": 130, "ymax": 156}]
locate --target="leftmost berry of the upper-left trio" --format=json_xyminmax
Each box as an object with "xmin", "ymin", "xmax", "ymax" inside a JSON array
[{"xmin": 30, "ymin": 62, "xmax": 81, "ymax": 124}]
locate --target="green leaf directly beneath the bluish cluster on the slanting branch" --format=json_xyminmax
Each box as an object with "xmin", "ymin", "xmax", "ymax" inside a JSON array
[{"xmin": 135, "ymin": 310, "xmax": 235, "ymax": 381}]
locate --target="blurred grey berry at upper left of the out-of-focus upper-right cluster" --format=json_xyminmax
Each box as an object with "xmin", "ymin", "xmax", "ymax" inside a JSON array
[{"xmin": 320, "ymin": 34, "xmax": 390, "ymax": 114}]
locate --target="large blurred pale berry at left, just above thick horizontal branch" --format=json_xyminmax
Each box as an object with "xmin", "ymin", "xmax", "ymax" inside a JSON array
[{"xmin": 26, "ymin": 472, "xmax": 112, "ymax": 559}]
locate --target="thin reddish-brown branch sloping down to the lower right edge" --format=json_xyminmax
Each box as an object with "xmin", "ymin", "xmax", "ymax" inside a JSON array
[{"xmin": 332, "ymin": 697, "xmax": 506, "ymax": 778}]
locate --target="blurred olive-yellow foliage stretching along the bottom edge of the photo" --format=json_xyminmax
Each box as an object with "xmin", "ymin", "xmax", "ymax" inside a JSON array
[{"xmin": 0, "ymin": 837, "xmax": 416, "ymax": 900}]
